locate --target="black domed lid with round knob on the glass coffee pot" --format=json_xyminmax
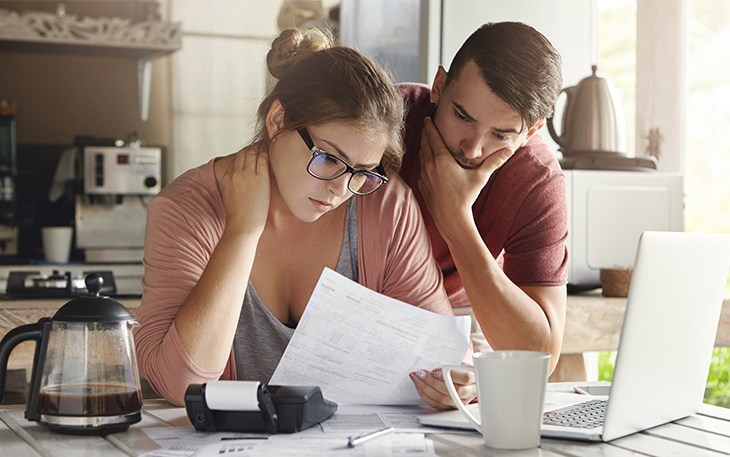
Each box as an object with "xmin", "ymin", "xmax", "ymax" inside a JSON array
[{"xmin": 53, "ymin": 273, "xmax": 134, "ymax": 323}]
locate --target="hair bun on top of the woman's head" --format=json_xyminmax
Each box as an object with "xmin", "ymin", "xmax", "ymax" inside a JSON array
[{"xmin": 266, "ymin": 29, "xmax": 335, "ymax": 79}]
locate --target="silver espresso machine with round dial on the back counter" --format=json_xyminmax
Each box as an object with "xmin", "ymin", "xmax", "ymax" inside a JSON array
[{"xmin": 74, "ymin": 137, "xmax": 162, "ymax": 263}]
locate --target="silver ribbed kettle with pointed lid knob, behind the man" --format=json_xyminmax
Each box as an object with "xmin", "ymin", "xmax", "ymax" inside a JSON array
[{"xmin": 547, "ymin": 65, "xmax": 627, "ymax": 157}]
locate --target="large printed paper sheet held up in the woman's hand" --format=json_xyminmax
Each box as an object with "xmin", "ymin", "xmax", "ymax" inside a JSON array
[{"xmin": 269, "ymin": 268, "xmax": 471, "ymax": 405}]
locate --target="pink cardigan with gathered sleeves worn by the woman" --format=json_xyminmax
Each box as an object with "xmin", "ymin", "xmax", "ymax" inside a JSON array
[{"xmin": 134, "ymin": 160, "xmax": 453, "ymax": 405}]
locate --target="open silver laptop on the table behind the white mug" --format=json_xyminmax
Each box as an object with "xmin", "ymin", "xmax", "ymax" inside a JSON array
[{"xmin": 418, "ymin": 232, "xmax": 730, "ymax": 441}]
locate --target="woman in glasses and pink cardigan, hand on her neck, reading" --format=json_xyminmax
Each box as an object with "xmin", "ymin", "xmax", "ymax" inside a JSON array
[{"xmin": 135, "ymin": 30, "xmax": 476, "ymax": 408}]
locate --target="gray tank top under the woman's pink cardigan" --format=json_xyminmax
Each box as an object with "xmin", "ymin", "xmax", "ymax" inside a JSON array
[{"xmin": 233, "ymin": 198, "xmax": 358, "ymax": 384}]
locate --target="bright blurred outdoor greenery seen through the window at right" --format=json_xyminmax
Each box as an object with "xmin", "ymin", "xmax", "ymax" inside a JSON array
[{"xmin": 597, "ymin": 0, "xmax": 730, "ymax": 407}]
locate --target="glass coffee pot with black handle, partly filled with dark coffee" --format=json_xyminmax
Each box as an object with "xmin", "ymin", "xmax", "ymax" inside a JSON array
[{"xmin": 0, "ymin": 273, "xmax": 142, "ymax": 435}]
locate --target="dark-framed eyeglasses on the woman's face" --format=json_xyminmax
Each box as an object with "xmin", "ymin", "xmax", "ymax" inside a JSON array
[{"xmin": 297, "ymin": 127, "xmax": 388, "ymax": 195}]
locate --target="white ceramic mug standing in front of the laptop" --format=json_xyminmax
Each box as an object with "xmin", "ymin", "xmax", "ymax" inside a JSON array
[{"xmin": 443, "ymin": 351, "xmax": 550, "ymax": 449}]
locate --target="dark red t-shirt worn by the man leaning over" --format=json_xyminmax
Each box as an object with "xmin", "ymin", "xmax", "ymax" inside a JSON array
[{"xmin": 398, "ymin": 83, "xmax": 568, "ymax": 306}]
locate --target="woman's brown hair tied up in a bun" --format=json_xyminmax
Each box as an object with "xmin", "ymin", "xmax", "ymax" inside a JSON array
[{"xmin": 255, "ymin": 29, "xmax": 404, "ymax": 171}]
